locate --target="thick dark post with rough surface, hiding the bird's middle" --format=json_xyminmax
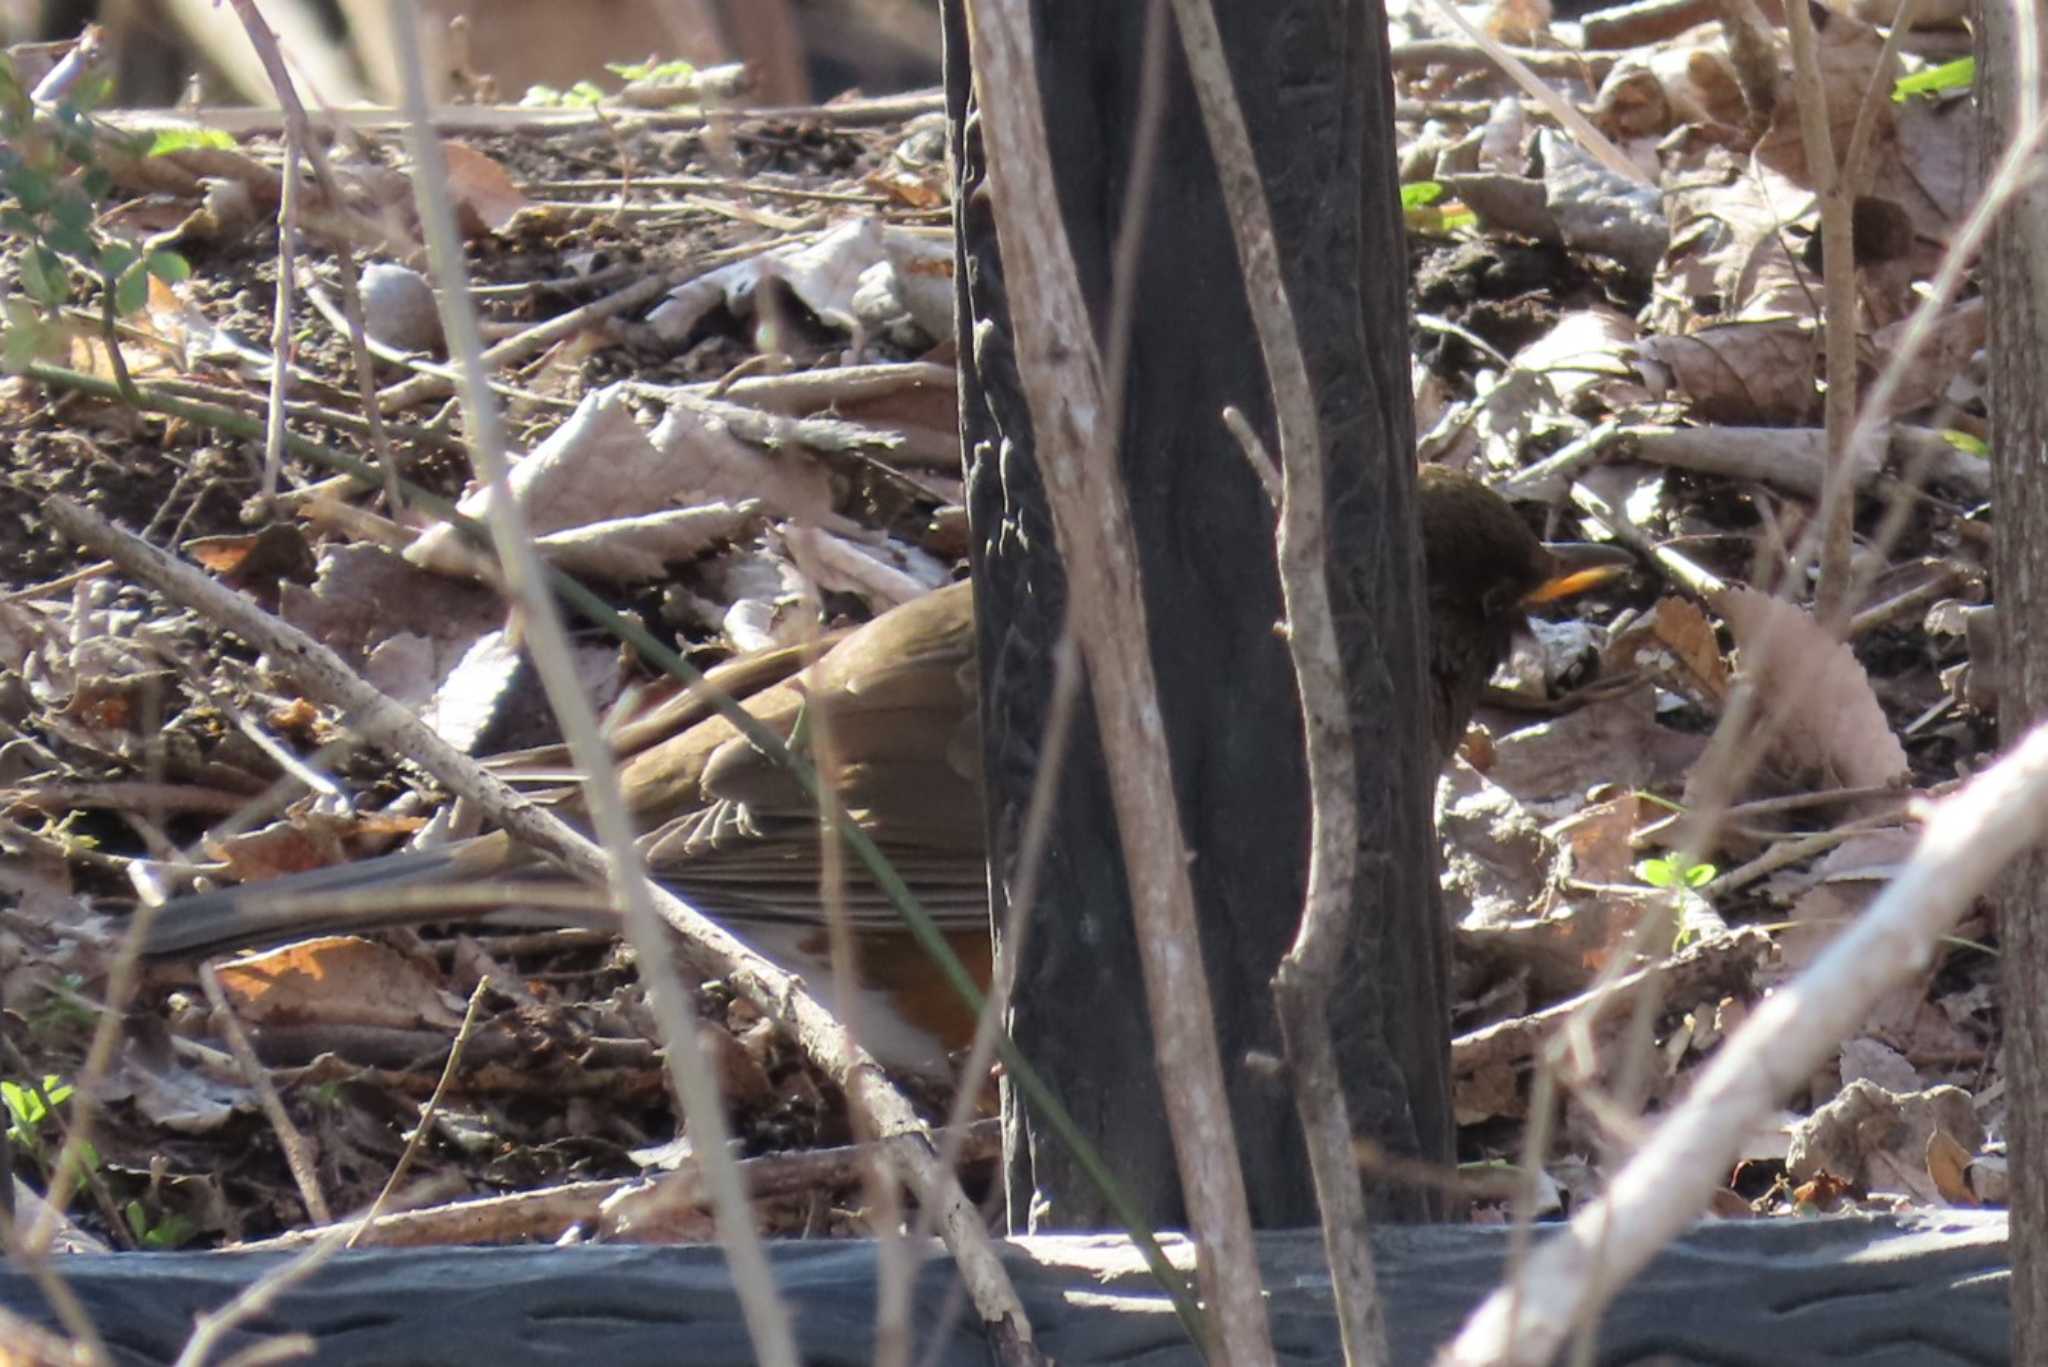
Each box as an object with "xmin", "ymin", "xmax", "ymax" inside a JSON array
[{"xmin": 946, "ymin": 0, "xmax": 1452, "ymax": 1230}]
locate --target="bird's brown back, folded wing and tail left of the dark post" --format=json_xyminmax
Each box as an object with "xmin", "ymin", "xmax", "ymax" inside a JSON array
[{"xmin": 150, "ymin": 584, "xmax": 985, "ymax": 953}]
